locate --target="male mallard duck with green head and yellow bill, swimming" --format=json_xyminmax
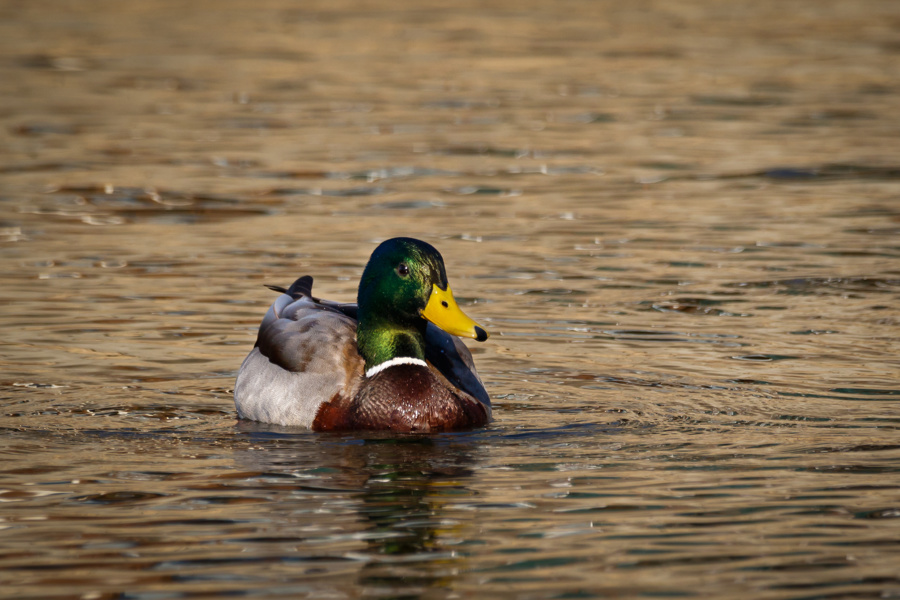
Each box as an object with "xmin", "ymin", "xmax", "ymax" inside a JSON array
[{"xmin": 234, "ymin": 238, "xmax": 491, "ymax": 432}]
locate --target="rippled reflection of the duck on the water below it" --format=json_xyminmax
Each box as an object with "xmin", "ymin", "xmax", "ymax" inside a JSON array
[{"xmin": 235, "ymin": 422, "xmax": 486, "ymax": 597}]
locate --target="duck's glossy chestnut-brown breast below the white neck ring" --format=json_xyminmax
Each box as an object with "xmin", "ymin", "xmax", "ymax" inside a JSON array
[{"xmin": 312, "ymin": 365, "xmax": 489, "ymax": 432}]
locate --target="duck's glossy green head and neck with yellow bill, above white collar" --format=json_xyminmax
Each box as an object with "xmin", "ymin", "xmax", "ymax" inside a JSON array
[{"xmin": 357, "ymin": 238, "xmax": 488, "ymax": 368}]
